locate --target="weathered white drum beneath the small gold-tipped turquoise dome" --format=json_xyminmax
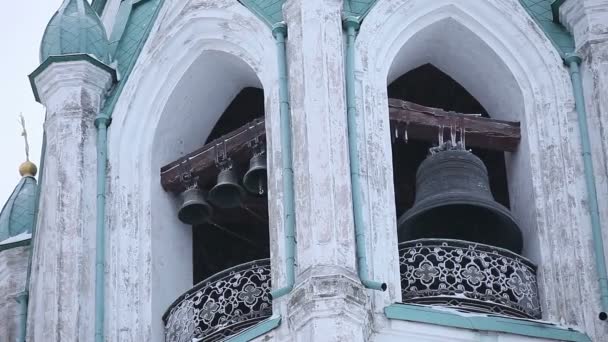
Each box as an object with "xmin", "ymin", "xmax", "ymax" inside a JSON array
[{"xmin": 0, "ymin": 246, "xmax": 30, "ymax": 341}]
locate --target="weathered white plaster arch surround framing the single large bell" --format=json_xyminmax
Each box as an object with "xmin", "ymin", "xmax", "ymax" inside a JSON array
[{"xmin": 357, "ymin": 0, "xmax": 608, "ymax": 338}]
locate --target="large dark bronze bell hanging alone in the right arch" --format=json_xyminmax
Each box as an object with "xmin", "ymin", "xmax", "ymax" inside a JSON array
[{"xmin": 397, "ymin": 149, "xmax": 523, "ymax": 253}]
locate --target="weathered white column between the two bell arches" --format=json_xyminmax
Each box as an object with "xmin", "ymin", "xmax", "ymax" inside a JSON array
[{"xmin": 283, "ymin": 0, "xmax": 369, "ymax": 342}]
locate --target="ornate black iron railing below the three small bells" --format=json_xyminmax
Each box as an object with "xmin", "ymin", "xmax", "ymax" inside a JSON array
[{"xmin": 163, "ymin": 259, "xmax": 272, "ymax": 342}]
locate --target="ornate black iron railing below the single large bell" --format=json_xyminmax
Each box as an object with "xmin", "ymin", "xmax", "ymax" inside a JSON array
[{"xmin": 399, "ymin": 239, "xmax": 541, "ymax": 319}]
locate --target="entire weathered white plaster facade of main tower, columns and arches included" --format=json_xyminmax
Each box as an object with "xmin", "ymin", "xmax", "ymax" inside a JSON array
[{"xmin": 25, "ymin": 0, "xmax": 608, "ymax": 342}]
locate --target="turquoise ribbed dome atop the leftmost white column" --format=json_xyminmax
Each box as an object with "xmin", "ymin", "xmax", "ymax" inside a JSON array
[{"xmin": 40, "ymin": 0, "xmax": 109, "ymax": 63}]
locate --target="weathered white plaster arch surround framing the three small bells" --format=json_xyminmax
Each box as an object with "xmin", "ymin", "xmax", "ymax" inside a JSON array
[{"xmin": 106, "ymin": 0, "xmax": 284, "ymax": 341}]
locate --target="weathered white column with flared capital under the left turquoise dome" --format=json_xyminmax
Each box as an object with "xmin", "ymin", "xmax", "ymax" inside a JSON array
[{"xmin": 28, "ymin": 59, "xmax": 113, "ymax": 342}]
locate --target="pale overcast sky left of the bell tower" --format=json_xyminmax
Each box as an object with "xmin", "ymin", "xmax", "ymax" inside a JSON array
[{"xmin": 0, "ymin": 0, "xmax": 62, "ymax": 207}]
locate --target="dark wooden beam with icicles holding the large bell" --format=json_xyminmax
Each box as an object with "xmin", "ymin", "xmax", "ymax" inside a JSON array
[{"xmin": 389, "ymin": 99, "xmax": 521, "ymax": 152}]
